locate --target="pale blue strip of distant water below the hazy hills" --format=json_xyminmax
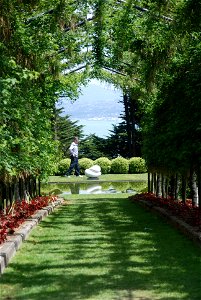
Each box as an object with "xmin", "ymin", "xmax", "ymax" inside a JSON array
[{"xmin": 75, "ymin": 118, "xmax": 122, "ymax": 138}]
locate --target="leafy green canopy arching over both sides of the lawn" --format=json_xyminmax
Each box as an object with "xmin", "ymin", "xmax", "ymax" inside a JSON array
[{"xmin": 0, "ymin": 0, "xmax": 201, "ymax": 206}]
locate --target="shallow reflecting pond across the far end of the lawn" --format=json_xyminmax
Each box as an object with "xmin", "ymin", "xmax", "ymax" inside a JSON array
[{"xmin": 41, "ymin": 181, "xmax": 147, "ymax": 195}]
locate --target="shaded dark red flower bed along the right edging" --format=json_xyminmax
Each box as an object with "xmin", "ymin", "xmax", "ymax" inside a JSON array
[{"xmin": 129, "ymin": 193, "xmax": 201, "ymax": 228}]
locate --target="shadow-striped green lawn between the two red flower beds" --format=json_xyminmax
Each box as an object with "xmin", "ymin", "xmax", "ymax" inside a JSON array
[{"xmin": 0, "ymin": 194, "xmax": 201, "ymax": 300}]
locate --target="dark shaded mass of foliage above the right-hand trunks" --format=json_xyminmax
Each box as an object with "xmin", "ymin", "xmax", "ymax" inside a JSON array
[{"xmin": 144, "ymin": 52, "xmax": 201, "ymax": 173}]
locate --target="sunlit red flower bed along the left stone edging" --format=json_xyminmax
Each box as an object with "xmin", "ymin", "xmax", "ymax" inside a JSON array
[{"xmin": 0, "ymin": 196, "xmax": 57, "ymax": 244}]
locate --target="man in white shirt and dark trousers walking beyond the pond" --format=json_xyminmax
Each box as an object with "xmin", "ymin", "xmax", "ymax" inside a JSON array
[{"xmin": 65, "ymin": 136, "xmax": 82, "ymax": 177}]
